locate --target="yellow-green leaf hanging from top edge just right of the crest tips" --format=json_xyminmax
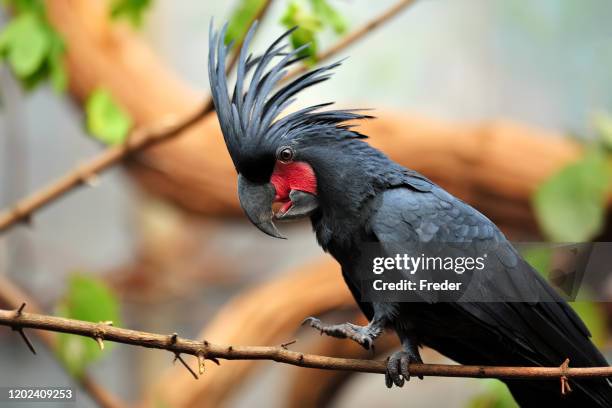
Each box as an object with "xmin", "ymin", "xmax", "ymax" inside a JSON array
[{"xmin": 281, "ymin": 2, "xmax": 323, "ymax": 64}]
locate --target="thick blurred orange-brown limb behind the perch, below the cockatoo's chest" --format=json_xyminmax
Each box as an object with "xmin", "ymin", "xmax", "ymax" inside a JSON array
[{"xmin": 143, "ymin": 257, "xmax": 354, "ymax": 408}]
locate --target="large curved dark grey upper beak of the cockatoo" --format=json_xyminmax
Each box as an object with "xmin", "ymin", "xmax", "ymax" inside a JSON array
[{"xmin": 238, "ymin": 174, "xmax": 285, "ymax": 239}]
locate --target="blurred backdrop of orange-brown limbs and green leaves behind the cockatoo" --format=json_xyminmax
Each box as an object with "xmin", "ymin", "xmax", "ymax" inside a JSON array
[{"xmin": 0, "ymin": 0, "xmax": 612, "ymax": 407}]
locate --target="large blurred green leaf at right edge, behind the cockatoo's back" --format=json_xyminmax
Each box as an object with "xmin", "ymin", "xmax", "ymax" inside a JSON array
[{"xmin": 532, "ymin": 150, "xmax": 611, "ymax": 242}]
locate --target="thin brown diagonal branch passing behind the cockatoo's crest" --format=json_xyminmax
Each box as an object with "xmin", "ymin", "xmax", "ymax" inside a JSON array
[{"xmin": 0, "ymin": 0, "xmax": 416, "ymax": 232}]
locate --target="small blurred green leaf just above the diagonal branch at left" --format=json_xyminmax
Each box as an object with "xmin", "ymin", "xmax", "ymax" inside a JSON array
[{"xmin": 85, "ymin": 89, "xmax": 132, "ymax": 145}]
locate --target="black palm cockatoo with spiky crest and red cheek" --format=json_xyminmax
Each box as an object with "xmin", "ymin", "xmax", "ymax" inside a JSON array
[{"xmin": 208, "ymin": 25, "xmax": 612, "ymax": 407}]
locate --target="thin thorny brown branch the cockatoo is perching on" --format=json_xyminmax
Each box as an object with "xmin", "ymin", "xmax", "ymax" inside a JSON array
[{"xmin": 0, "ymin": 310, "xmax": 612, "ymax": 383}]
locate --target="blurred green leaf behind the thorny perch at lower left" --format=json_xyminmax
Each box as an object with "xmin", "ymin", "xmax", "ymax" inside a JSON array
[{"xmin": 55, "ymin": 274, "xmax": 121, "ymax": 377}]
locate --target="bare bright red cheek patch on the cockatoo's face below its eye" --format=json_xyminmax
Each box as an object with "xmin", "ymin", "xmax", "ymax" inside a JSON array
[{"xmin": 270, "ymin": 161, "xmax": 317, "ymax": 201}]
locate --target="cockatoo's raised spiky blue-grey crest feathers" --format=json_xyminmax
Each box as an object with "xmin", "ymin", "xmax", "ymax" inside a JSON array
[{"xmin": 208, "ymin": 22, "xmax": 370, "ymax": 171}]
